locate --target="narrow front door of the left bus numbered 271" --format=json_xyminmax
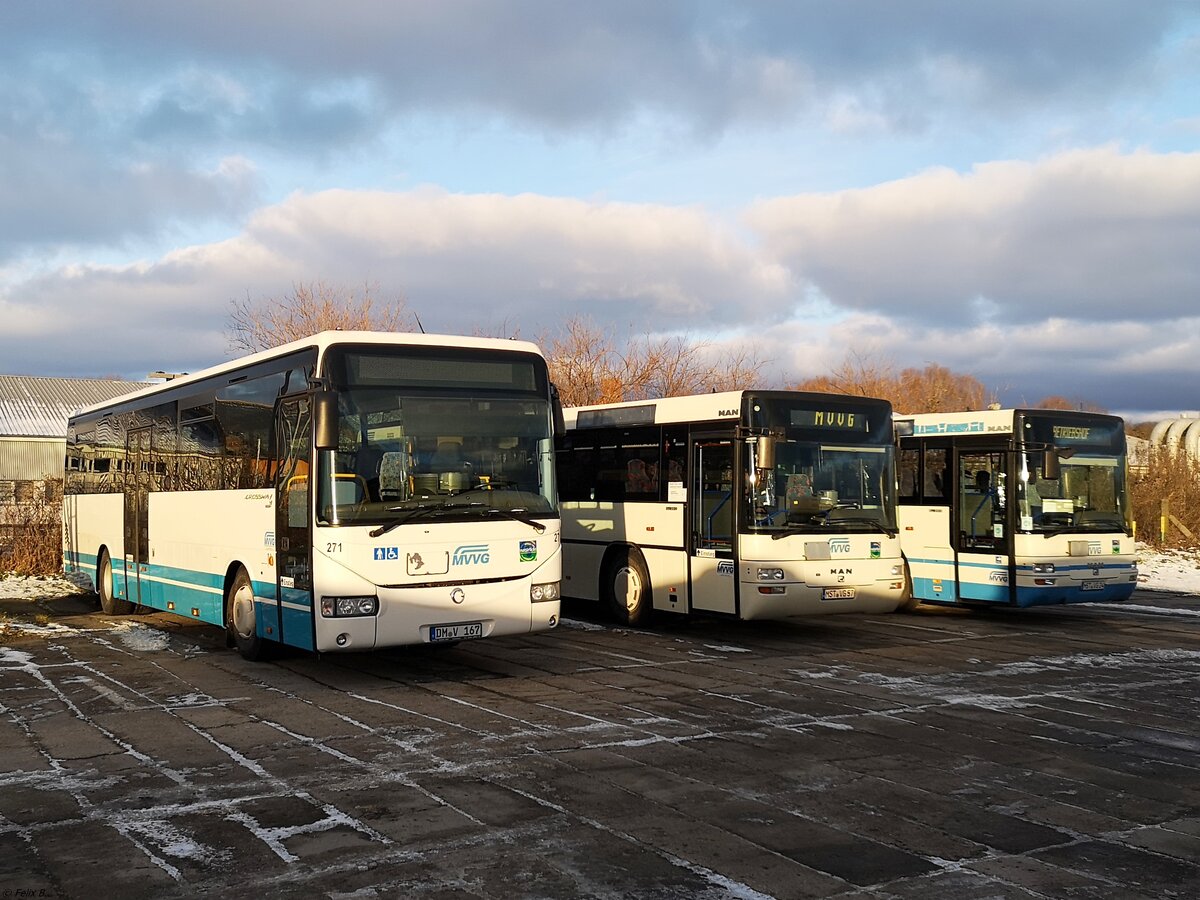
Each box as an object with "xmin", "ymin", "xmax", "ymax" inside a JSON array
[{"xmin": 273, "ymin": 395, "xmax": 316, "ymax": 650}]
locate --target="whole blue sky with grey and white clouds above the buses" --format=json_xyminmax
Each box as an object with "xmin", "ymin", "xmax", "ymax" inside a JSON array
[{"xmin": 0, "ymin": 0, "xmax": 1200, "ymax": 421}]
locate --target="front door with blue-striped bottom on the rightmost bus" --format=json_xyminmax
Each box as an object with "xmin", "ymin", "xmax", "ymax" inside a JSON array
[{"xmin": 950, "ymin": 448, "xmax": 1015, "ymax": 604}]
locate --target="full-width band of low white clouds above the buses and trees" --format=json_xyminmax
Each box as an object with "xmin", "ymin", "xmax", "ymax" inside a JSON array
[{"xmin": 7, "ymin": 149, "xmax": 1200, "ymax": 409}]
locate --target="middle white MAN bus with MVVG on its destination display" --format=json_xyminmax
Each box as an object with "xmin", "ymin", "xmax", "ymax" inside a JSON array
[{"xmin": 558, "ymin": 391, "xmax": 904, "ymax": 624}]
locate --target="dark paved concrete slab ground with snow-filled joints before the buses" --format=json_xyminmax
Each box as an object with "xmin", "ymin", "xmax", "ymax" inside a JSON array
[{"xmin": 0, "ymin": 594, "xmax": 1200, "ymax": 900}]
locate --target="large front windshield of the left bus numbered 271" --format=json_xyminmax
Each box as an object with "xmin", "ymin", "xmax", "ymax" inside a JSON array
[{"xmin": 317, "ymin": 348, "xmax": 557, "ymax": 526}]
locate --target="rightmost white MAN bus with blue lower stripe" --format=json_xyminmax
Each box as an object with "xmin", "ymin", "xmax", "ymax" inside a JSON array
[{"xmin": 895, "ymin": 409, "xmax": 1138, "ymax": 608}]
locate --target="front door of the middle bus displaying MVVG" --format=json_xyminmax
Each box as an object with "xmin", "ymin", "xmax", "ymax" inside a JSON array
[{"xmin": 688, "ymin": 436, "xmax": 738, "ymax": 613}]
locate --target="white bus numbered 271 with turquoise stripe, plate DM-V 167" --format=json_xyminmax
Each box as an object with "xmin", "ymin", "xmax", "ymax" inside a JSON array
[{"xmin": 64, "ymin": 331, "xmax": 562, "ymax": 659}]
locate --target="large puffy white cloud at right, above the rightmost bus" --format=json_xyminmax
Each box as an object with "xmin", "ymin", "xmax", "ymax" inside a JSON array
[{"xmin": 746, "ymin": 148, "xmax": 1200, "ymax": 328}]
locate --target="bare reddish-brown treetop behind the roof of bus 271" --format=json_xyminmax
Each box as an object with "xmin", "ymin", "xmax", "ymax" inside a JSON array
[{"xmin": 228, "ymin": 281, "xmax": 415, "ymax": 353}]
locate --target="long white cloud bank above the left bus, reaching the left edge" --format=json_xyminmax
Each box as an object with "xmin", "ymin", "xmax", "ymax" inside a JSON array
[{"xmin": 0, "ymin": 188, "xmax": 791, "ymax": 374}]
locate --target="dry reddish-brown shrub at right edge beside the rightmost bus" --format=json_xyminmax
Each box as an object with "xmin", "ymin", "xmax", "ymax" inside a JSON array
[{"xmin": 1129, "ymin": 446, "xmax": 1200, "ymax": 548}]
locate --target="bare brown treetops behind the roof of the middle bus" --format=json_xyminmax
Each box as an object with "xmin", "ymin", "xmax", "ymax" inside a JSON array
[{"xmin": 539, "ymin": 316, "xmax": 764, "ymax": 407}]
